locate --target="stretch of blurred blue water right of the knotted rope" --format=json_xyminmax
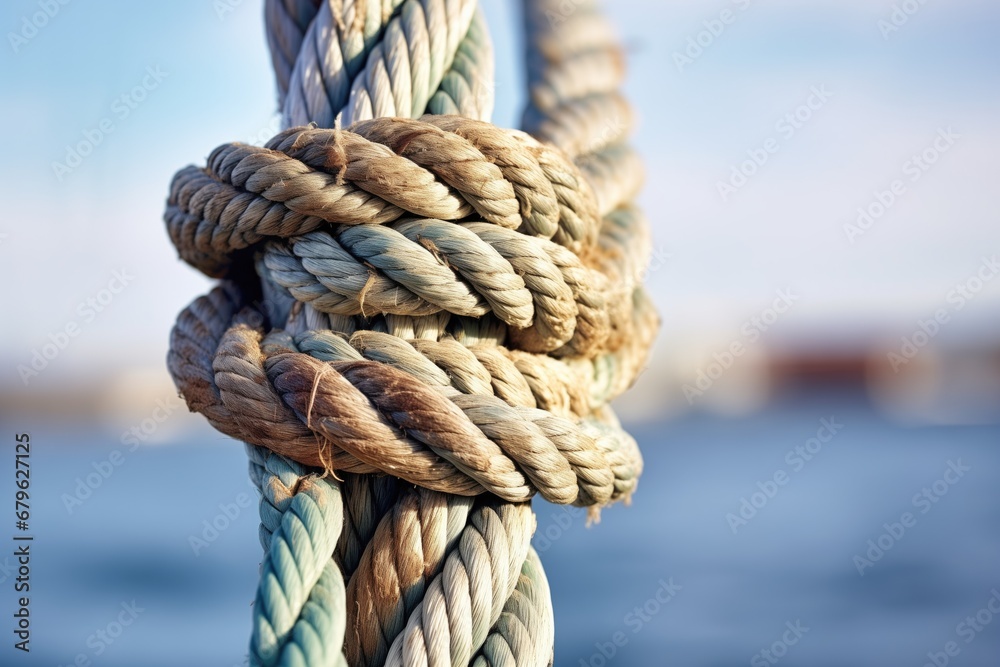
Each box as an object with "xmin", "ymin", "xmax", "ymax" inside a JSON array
[{"xmin": 539, "ymin": 396, "xmax": 1000, "ymax": 667}]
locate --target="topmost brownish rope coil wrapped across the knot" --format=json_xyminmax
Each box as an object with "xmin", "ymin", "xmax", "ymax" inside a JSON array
[{"xmin": 166, "ymin": 116, "xmax": 598, "ymax": 275}]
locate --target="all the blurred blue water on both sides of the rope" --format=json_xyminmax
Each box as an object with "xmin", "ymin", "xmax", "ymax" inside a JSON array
[{"xmin": 0, "ymin": 388, "xmax": 1000, "ymax": 667}]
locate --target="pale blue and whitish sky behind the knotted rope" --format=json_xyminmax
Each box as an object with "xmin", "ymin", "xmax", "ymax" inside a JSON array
[{"xmin": 0, "ymin": 0, "xmax": 1000, "ymax": 389}]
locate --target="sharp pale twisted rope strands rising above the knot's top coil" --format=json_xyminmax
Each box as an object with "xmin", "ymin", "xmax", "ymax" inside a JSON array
[{"xmin": 280, "ymin": 0, "xmax": 492, "ymax": 127}]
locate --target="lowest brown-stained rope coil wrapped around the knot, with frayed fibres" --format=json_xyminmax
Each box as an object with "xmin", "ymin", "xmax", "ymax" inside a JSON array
[{"xmin": 171, "ymin": 286, "xmax": 641, "ymax": 505}]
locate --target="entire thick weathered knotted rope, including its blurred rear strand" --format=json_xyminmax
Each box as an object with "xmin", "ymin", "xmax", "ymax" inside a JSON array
[{"xmin": 165, "ymin": 0, "xmax": 658, "ymax": 667}]
